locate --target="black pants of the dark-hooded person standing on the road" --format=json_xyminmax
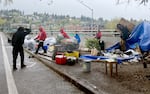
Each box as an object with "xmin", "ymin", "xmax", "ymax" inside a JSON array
[{"xmin": 12, "ymin": 46, "xmax": 24, "ymax": 68}]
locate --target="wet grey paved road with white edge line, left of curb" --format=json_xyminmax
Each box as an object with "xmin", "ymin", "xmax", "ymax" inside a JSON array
[{"xmin": 0, "ymin": 32, "xmax": 84, "ymax": 94}]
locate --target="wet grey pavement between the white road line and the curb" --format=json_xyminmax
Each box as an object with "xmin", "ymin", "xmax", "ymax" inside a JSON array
[{"xmin": 13, "ymin": 55, "xmax": 84, "ymax": 94}]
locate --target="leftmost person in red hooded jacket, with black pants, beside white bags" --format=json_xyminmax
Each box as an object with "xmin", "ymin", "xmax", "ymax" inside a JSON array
[{"xmin": 35, "ymin": 26, "xmax": 47, "ymax": 54}]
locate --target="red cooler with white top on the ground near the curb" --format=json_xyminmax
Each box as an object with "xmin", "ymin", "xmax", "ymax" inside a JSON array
[{"xmin": 55, "ymin": 55, "xmax": 67, "ymax": 65}]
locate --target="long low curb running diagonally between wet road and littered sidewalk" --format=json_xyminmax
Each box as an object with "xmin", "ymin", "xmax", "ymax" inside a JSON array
[{"xmin": 24, "ymin": 49, "xmax": 106, "ymax": 94}]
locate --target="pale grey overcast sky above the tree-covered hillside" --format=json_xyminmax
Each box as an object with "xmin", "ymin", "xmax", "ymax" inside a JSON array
[{"xmin": 0, "ymin": 0, "xmax": 150, "ymax": 20}]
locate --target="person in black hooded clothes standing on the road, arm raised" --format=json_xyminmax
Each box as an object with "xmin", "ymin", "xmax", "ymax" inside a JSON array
[{"xmin": 12, "ymin": 27, "xmax": 31, "ymax": 70}]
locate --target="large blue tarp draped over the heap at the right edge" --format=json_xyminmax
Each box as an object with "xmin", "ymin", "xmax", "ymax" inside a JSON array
[{"xmin": 106, "ymin": 22, "xmax": 150, "ymax": 51}]
